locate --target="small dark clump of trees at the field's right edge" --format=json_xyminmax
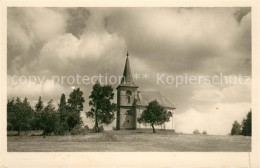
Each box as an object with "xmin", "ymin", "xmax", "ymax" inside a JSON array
[{"xmin": 230, "ymin": 109, "xmax": 252, "ymax": 136}]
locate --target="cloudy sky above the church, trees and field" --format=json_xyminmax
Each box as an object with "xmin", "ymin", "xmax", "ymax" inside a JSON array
[{"xmin": 7, "ymin": 7, "xmax": 251, "ymax": 135}]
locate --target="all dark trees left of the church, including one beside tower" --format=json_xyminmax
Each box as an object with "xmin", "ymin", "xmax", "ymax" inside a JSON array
[{"xmin": 7, "ymin": 82, "xmax": 116, "ymax": 135}]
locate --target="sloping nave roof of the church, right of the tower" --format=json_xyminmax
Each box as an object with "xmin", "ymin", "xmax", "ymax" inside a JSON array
[{"xmin": 137, "ymin": 91, "xmax": 176, "ymax": 109}]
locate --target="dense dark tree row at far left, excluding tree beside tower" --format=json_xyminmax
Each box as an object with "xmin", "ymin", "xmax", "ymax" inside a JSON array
[{"xmin": 7, "ymin": 89, "xmax": 85, "ymax": 135}]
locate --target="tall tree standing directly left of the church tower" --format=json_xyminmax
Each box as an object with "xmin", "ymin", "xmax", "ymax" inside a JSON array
[{"xmin": 86, "ymin": 81, "xmax": 116, "ymax": 132}]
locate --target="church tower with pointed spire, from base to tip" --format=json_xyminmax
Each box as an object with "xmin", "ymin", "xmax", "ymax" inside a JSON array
[{"xmin": 116, "ymin": 52, "xmax": 138, "ymax": 130}]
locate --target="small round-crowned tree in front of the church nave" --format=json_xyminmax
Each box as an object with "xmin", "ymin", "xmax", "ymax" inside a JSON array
[{"xmin": 138, "ymin": 100, "xmax": 170, "ymax": 133}]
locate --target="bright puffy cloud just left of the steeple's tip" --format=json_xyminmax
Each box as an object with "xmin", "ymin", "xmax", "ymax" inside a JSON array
[{"xmin": 32, "ymin": 33, "xmax": 124, "ymax": 74}]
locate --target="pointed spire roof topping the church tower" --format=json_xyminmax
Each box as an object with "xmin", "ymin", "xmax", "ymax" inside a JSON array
[{"xmin": 118, "ymin": 51, "xmax": 138, "ymax": 87}]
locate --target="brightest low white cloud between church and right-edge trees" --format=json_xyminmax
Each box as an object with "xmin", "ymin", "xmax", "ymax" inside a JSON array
[{"xmin": 175, "ymin": 102, "xmax": 251, "ymax": 135}]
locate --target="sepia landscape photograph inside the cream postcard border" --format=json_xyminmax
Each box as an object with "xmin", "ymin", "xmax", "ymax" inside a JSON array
[{"xmin": 6, "ymin": 7, "xmax": 255, "ymax": 152}]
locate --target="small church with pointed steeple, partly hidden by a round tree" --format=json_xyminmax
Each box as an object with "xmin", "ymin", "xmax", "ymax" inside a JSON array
[{"xmin": 116, "ymin": 52, "xmax": 176, "ymax": 130}]
